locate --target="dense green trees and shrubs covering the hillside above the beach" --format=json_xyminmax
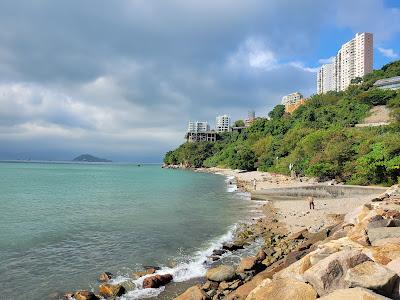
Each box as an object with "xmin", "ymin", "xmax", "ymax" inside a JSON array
[{"xmin": 164, "ymin": 61, "xmax": 400, "ymax": 185}]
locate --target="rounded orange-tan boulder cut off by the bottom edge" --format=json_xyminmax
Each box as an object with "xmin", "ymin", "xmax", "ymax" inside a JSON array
[{"xmin": 246, "ymin": 278, "xmax": 317, "ymax": 300}]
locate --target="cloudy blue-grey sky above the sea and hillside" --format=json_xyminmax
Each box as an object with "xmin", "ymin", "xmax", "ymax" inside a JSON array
[{"xmin": 0, "ymin": 0, "xmax": 400, "ymax": 162}]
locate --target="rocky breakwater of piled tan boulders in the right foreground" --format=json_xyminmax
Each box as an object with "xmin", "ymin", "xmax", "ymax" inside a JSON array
[{"xmin": 176, "ymin": 186, "xmax": 400, "ymax": 300}]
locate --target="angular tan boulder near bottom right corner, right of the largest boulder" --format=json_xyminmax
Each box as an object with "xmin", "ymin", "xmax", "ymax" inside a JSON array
[{"xmin": 344, "ymin": 261, "xmax": 398, "ymax": 296}]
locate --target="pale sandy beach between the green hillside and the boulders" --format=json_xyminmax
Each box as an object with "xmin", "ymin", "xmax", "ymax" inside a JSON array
[{"xmin": 198, "ymin": 168, "xmax": 385, "ymax": 233}]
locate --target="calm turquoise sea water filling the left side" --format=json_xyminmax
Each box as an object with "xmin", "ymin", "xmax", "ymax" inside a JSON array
[{"xmin": 0, "ymin": 163, "xmax": 255, "ymax": 299}]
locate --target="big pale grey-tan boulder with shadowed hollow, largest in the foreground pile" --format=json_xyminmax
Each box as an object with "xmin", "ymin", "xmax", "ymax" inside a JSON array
[{"xmin": 303, "ymin": 250, "xmax": 370, "ymax": 296}]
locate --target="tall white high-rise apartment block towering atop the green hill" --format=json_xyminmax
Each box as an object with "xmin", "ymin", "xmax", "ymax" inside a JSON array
[{"xmin": 317, "ymin": 32, "xmax": 373, "ymax": 93}]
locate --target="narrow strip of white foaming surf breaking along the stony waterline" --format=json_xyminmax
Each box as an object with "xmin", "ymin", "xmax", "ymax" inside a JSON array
[{"xmin": 62, "ymin": 170, "xmax": 261, "ymax": 300}]
